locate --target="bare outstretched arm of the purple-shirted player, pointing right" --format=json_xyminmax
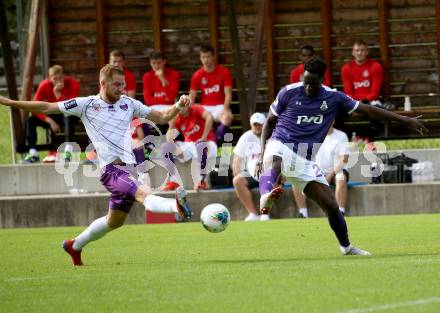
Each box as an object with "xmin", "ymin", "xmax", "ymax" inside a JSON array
[{"xmin": 356, "ymin": 102, "xmax": 428, "ymax": 135}]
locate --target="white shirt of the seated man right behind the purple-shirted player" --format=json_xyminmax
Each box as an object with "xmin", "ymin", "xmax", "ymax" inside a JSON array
[{"xmin": 315, "ymin": 128, "xmax": 350, "ymax": 174}]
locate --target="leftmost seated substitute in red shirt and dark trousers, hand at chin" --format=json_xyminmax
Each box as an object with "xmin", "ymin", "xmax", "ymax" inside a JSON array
[{"xmin": 23, "ymin": 65, "xmax": 80, "ymax": 163}]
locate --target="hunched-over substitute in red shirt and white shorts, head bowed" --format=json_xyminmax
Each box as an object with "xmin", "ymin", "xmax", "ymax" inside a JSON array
[{"xmin": 161, "ymin": 105, "xmax": 217, "ymax": 190}]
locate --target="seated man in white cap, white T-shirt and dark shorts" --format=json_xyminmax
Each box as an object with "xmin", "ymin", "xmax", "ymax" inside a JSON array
[{"xmin": 232, "ymin": 113, "xmax": 266, "ymax": 222}]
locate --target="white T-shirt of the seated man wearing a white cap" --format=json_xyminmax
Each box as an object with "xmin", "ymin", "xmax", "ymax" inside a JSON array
[{"xmin": 234, "ymin": 130, "xmax": 261, "ymax": 181}]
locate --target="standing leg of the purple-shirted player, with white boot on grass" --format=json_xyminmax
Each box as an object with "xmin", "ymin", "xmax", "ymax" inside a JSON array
[{"xmin": 304, "ymin": 181, "xmax": 371, "ymax": 255}]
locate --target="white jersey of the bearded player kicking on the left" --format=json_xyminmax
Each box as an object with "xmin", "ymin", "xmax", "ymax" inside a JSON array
[{"xmin": 58, "ymin": 95, "xmax": 152, "ymax": 168}]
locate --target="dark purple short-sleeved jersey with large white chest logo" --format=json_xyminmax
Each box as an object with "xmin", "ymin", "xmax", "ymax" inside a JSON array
[{"xmin": 270, "ymin": 82, "xmax": 359, "ymax": 160}]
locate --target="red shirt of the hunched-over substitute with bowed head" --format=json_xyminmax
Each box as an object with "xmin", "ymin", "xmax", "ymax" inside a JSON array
[{"xmin": 175, "ymin": 105, "xmax": 216, "ymax": 142}]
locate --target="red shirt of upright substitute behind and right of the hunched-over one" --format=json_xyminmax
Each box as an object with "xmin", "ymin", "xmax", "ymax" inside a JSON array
[{"xmin": 191, "ymin": 64, "xmax": 232, "ymax": 105}]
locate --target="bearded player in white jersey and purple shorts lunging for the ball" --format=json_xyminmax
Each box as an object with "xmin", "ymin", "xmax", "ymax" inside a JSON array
[{"xmin": 0, "ymin": 64, "xmax": 192, "ymax": 265}]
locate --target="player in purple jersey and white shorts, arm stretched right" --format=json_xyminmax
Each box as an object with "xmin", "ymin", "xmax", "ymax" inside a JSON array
[{"xmin": 257, "ymin": 58, "xmax": 427, "ymax": 255}]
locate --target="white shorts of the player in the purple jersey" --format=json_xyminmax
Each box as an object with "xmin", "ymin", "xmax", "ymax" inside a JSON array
[{"xmin": 263, "ymin": 140, "xmax": 328, "ymax": 191}]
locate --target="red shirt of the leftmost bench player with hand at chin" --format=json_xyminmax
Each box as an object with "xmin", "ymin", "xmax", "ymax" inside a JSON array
[{"xmin": 32, "ymin": 76, "xmax": 80, "ymax": 121}]
